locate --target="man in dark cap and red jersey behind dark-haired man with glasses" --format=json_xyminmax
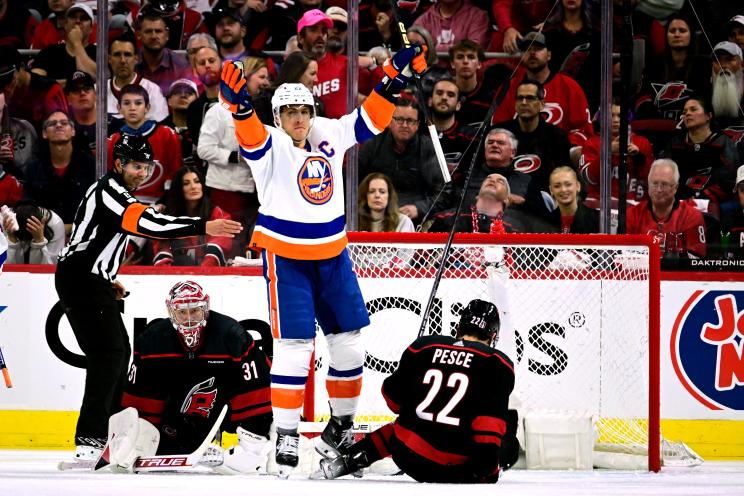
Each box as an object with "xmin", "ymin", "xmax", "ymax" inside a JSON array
[{"xmin": 492, "ymin": 32, "xmax": 594, "ymax": 146}]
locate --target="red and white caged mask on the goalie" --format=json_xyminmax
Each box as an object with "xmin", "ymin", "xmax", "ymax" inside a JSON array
[{"xmin": 165, "ymin": 281, "xmax": 209, "ymax": 351}]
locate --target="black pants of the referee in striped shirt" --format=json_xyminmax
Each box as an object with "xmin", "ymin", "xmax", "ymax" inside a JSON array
[{"xmin": 54, "ymin": 262, "xmax": 132, "ymax": 445}]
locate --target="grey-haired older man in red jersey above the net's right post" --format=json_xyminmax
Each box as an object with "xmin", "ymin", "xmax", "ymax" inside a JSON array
[{"xmin": 628, "ymin": 159, "xmax": 706, "ymax": 264}]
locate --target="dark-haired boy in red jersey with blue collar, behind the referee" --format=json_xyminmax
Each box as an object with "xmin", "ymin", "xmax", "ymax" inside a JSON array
[{"xmin": 108, "ymin": 84, "xmax": 182, "ymax": 204}]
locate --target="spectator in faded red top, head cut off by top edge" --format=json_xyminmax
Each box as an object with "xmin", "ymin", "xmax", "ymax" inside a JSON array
[{"xmin": 414, "ymin": 0, "xmax": 490, "ymax": 52}]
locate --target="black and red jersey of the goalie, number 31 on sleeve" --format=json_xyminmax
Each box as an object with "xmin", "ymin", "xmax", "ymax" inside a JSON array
[{"xmin": 122, "ymin": 310, "xmax": 272, "ymax": 454}]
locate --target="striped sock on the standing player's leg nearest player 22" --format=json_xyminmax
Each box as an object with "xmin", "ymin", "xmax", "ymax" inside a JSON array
[{"xmin": 326, "ymin": 330, "xmax": 364, "ymax": 417}]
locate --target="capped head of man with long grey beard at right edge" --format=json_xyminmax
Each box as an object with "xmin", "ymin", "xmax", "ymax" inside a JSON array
[{"xmin": 711, "ymin": 41, "xmax": 744, "ymax": 128}]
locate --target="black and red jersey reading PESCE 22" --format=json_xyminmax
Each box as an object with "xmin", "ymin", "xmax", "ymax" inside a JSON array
[{"xmin": 382, "ymin": 336, "xmax": 514, "ymax": 476}]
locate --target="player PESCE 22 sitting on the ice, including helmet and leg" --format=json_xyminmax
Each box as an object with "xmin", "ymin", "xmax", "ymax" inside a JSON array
[{"xmin": 320, "ymin": 299, "xmax": 519, "ymax": 483}]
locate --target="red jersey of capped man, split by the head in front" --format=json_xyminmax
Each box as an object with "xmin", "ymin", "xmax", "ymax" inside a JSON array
[{"xmin": 491, "ymin": 70, "xmax": 594, "ymax": 146}]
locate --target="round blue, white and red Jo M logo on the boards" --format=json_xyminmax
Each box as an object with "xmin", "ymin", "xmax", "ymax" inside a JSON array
[{"xmin": 670, "ymin": 290, "xmax": 744, "ymax": 410}]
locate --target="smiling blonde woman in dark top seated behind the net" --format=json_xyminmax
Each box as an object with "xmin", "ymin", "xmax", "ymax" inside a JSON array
[{"xmin": 549, "ymin": 166, "xmax": 599, "ymax": 234}]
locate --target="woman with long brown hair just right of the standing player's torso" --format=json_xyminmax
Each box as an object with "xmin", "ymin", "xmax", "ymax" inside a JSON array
[{"xmin": 357, "ymin": 172, "xmax": 414, "ymax": 232}]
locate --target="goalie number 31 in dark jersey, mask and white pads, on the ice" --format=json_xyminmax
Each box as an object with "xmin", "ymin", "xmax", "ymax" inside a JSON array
[{"xmin": 107, "ymin": 281, "xmax": 272, "ymax": 473}]
